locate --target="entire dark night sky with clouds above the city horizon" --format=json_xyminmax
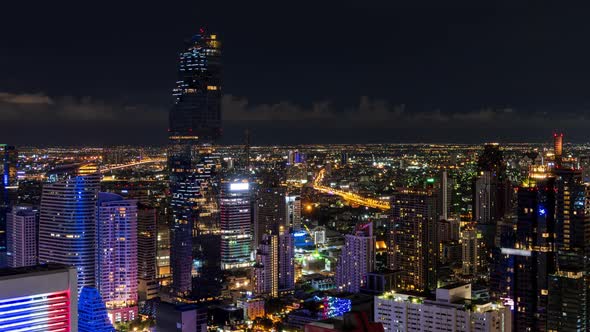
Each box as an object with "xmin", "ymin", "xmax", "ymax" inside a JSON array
[{"xmin": 0, "ymin": 1, "xmax": 590, "ymax": 145}]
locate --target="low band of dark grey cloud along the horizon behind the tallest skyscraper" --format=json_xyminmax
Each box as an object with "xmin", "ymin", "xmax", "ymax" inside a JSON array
[{"xmin": 0, "ymin": 92, "xmax": 590, "ymax": 145}]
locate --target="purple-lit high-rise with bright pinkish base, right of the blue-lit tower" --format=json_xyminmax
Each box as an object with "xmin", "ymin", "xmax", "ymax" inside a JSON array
[{"xmin": 96, "ymin": 192, "xmax": 137, "ymax": 323}]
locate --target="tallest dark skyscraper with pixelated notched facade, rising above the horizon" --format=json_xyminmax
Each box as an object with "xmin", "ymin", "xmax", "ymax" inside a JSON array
[{"xmin": 168, "ymin": 29, "xmax": 222, "ymax": 295}]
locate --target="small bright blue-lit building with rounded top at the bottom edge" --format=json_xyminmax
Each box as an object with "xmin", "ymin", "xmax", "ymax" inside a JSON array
[{"xmin": 78, "ymin": 286, "xmax": 115, "ymax": 332}]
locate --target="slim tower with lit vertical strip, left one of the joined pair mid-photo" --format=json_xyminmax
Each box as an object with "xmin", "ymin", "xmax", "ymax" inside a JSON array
[{"xmin": 254, "ymin": 234, "xmax": 279, "ymax": 297}]
